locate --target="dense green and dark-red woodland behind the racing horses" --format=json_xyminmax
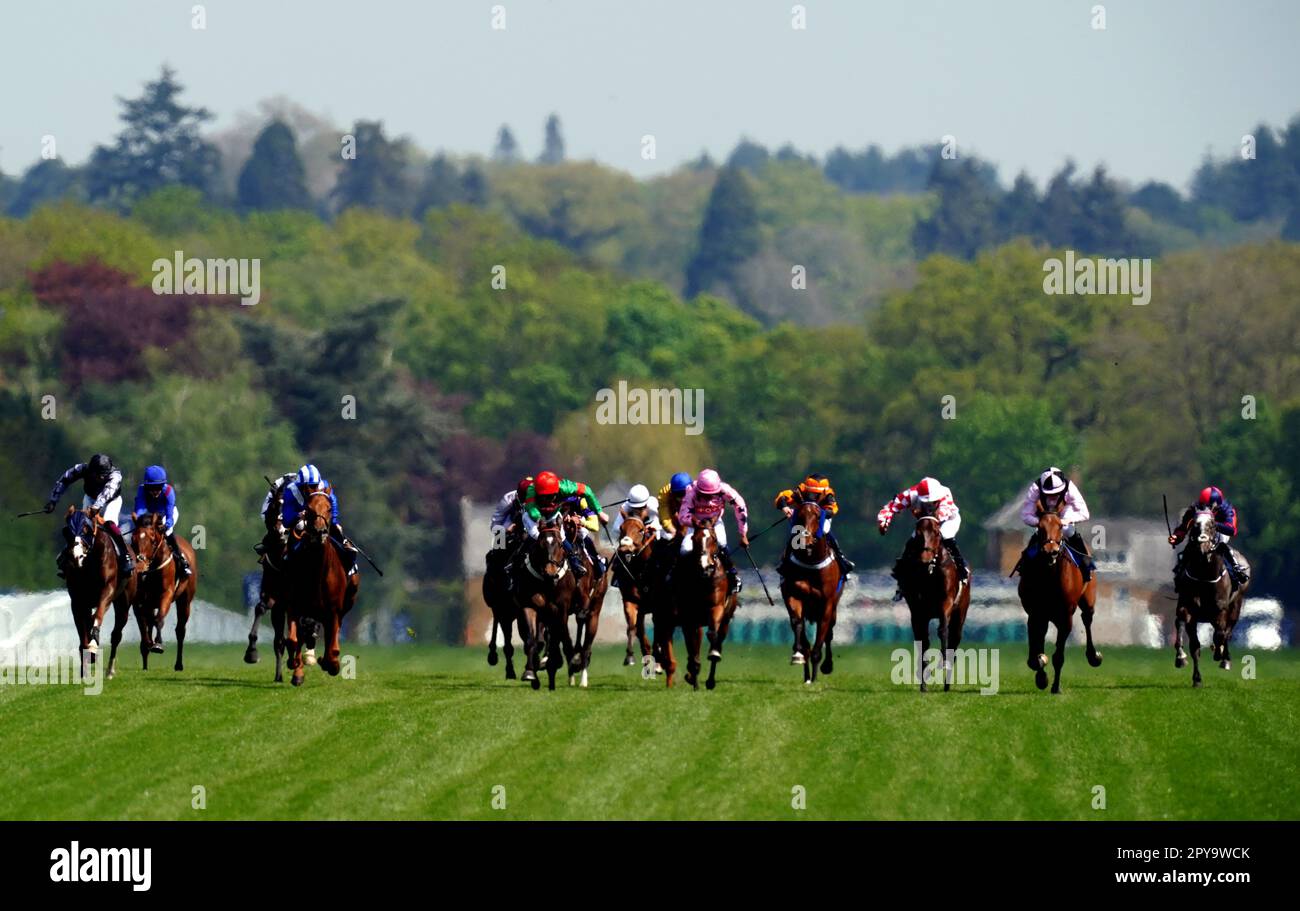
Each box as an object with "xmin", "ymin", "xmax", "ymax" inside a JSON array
[{"xmin": 0, "ymin": 67, "xmax": 1300, "ymax": 634}]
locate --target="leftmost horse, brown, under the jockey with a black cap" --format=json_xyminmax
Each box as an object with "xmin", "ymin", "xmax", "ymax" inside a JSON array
[{"xmin": 64, "ymin": 506, "xmax": 134, "ymax": 678}]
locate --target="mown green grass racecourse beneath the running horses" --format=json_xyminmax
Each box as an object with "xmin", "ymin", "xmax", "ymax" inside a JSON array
[{"xmin": 0, "ymin": 639, "xmax": 1300, "ymax": 820}]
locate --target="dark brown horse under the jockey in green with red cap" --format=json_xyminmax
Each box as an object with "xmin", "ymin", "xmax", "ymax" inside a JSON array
[{"xmin": 515, "ymin": 512, "xmax": 577, "ymax": 690}]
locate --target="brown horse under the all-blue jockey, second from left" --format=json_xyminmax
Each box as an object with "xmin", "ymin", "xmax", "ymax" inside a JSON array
[{"xmin": 131, "ymin": 513, "xmax": 199, "ymax": 671}]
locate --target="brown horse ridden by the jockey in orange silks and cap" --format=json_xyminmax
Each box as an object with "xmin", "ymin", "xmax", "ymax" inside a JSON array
[{"xmin": 781, "ymin": 503, "xmax": 844, "ymax": 684}]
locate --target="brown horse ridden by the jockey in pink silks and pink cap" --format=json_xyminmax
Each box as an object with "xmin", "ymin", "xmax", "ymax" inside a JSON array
[{"xmin": 654, "ymin": 519, "xmax": 738, "ymax": 690}]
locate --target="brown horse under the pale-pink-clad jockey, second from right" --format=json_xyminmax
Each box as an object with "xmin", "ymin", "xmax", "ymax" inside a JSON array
[{"xmin": 1018, "ymin": 504, "xmax": 1101, "ymax": 693}]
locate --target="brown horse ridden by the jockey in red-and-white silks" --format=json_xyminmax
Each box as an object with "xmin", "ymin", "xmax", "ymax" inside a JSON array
[{"xmin": 898, "ymin": 516, "xmax": 971, "ymax": 693}]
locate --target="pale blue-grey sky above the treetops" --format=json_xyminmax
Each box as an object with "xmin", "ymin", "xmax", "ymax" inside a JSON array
[{"xmin": 0, "ymin": 0, "xmax": 1300, "ymax": 186}]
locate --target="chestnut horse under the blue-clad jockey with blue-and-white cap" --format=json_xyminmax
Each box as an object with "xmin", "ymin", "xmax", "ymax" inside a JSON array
[{"xmin": 285, "ymin": 491, "xmax": 360, "ymax": 686}]
